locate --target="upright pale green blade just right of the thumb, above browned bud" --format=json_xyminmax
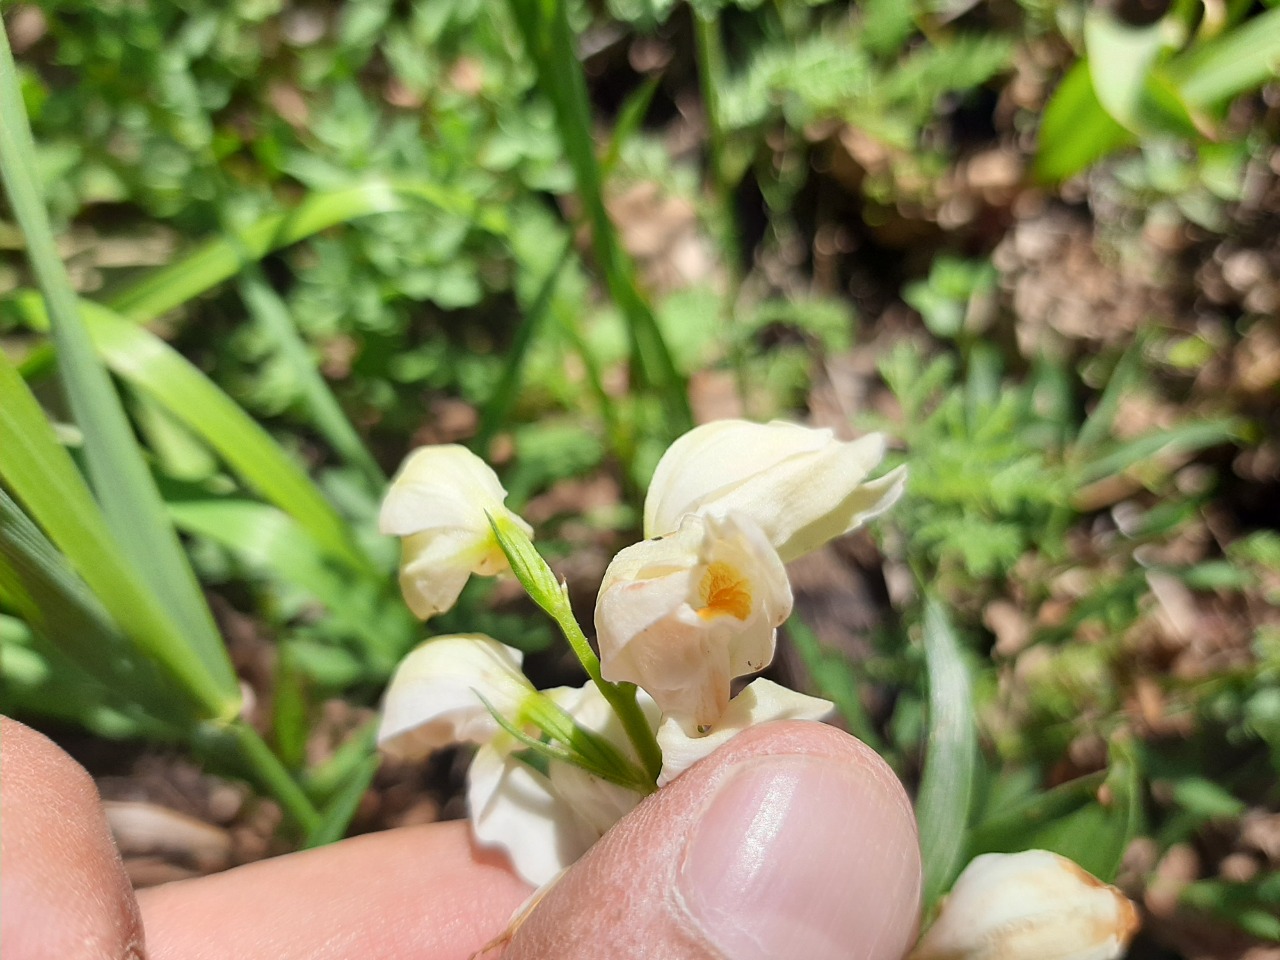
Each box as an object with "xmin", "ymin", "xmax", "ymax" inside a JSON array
[{"xmin": 915, "ymin": 596, "xmax": 978, "ymax": 910}]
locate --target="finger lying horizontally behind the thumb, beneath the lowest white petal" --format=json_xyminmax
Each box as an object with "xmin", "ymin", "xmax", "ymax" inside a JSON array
[{"xmin": 138, "ymin": 822, "xmax": 531, "ymax": 960}]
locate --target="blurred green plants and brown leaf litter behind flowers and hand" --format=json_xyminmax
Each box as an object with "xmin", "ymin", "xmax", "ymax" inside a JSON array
[{"xmin": 0, "ymin": 0, "xmax": 1280, "ymax": 957}]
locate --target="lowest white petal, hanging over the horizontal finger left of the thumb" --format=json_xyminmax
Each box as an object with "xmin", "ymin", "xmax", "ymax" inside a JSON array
[{"xmin": 467, "ymin": 744, "xmax": 599, "ymax": 887}]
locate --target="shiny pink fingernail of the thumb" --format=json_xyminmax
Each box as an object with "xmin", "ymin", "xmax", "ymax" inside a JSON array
[{"xmin": 677, "ymin": 756, "xmax": 919, "ymax": 960}]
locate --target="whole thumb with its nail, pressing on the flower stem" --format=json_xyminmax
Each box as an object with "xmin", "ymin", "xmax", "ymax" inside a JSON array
[{"xmin": 503, "ymin": 722, "xmax": 920, "ymax": 960}]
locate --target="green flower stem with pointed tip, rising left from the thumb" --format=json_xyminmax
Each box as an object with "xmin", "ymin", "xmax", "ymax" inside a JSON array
[{"xmin": 489, "ymin": 515, "xmax": 662, "ymax": 782}]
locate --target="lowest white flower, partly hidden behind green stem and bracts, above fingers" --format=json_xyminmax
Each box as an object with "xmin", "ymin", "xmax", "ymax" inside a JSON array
[{"xmin": 467, "ymin": 684, "xmax": 658, "ymax": 886}]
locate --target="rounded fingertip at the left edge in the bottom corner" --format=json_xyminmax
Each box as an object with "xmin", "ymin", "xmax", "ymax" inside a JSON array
[{"xmin": 0, "ymin": 717, "xmax": 143, "ymax": 960}]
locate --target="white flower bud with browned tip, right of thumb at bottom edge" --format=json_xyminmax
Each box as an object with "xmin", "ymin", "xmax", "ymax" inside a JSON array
[{"xmin": 909, "ymin": 850, "xmax": 1139, "ymax": 960}]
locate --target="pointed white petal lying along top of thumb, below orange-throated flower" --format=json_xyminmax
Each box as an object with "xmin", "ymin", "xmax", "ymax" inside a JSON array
[{"xmin": 658, "ymin": 677, "xmax": 836, "ymax": 787}]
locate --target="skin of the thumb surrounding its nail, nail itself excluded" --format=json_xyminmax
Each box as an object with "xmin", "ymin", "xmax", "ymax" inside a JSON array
[{"xmin": 502, "ymin": 721, "xmax": 920, "ymax": 960}]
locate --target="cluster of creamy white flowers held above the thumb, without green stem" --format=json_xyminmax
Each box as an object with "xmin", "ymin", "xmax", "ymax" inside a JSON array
[{"xmin": 379, "ymin": 420, "xmax": 905, "ymax": 884}]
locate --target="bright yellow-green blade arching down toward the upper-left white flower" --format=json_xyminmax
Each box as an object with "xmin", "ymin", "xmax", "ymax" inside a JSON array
[{"xmin": 14, "ymin": 294, "xmax": 380, "ymax": 576}]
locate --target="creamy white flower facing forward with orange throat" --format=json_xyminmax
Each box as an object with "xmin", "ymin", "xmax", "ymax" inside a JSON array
[{"xmin": 595, "ymin": 513, "xmax": 791, "ymax": 726}]
